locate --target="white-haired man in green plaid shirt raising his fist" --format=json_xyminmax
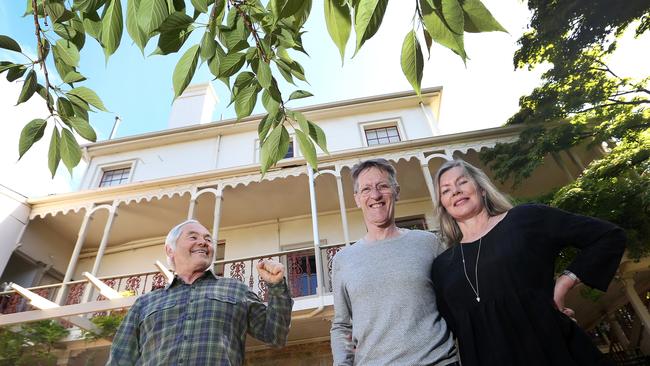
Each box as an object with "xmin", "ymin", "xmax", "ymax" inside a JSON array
[{"xmin": 108, "ymin": 220, "xmax": 293, "ymax": 365}]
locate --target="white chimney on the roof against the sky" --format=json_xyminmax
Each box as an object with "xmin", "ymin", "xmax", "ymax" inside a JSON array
[{"xmin": 167, "ymin": 82, "xmax": 219, "ymax": 128}]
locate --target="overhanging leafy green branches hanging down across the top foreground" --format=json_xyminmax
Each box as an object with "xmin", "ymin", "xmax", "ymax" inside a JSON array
[{"xmin": 0, "ymin": 0, "xmax": 504, "ymax": 176}]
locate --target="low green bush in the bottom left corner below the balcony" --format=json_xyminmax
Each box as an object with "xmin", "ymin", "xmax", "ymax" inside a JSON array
[{"xmin": 0, "ymin": 320, "xmax": 69, "ymax": 366}]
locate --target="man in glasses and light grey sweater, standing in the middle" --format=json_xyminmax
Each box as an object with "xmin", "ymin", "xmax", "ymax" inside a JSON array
[{"xmin": 331, "ymin": 159, "xmax": 458, "ymax": 366}]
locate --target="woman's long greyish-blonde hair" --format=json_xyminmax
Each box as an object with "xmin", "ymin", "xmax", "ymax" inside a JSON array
[{"xmin": 434, "ymin": 159, "xmax": 512, "ymax": 246}]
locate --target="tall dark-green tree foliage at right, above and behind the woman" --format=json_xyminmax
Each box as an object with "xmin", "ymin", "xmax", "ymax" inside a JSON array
[{"xmin": 481, "ymin": 0, "xmax": 650, "ymax": 260}]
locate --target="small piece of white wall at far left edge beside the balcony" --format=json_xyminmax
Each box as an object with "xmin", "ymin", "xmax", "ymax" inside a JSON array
[{"xmin": 0, "ymin": 186, "xmax": 31, "ymax": 274}]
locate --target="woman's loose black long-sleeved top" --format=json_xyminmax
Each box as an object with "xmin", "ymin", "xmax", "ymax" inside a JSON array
[{"xmin": 433, "ymin": 205, "xmax": 625, "ymax": 366}]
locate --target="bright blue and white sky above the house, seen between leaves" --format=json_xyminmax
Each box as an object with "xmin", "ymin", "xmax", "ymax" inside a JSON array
[{"xmin": 0, "ymin": 0, "xmax": 650, "ymax": 196}]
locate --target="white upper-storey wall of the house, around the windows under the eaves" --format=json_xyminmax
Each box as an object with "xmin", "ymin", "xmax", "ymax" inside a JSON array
[{"xmin": 81, "ymin": 103, "xmax": 433, "ymax": 189}]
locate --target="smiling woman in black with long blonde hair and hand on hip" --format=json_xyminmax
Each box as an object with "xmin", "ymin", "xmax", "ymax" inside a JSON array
[{"xmin": 432, "ymin": 160, "xmax": 625, "ymax": 366}]
